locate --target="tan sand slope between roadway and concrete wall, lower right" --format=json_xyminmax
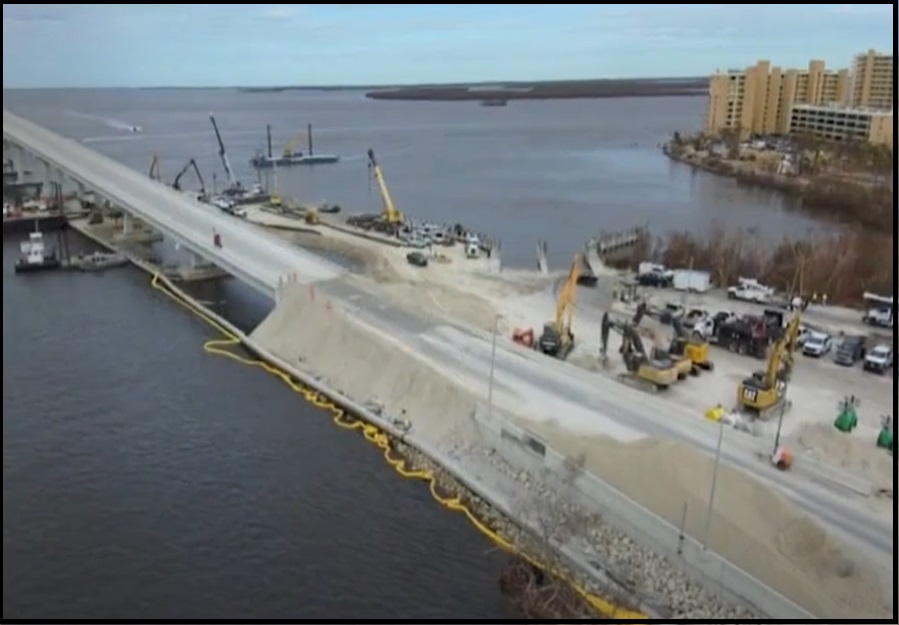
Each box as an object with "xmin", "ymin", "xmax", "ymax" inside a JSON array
[{"xmin": 528, "ymin": 424, "xmax": 892, "ymax": 621}]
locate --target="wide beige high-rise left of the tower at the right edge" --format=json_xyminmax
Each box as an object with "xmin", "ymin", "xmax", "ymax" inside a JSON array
[{"xmin": 705, "ymin": 61, "xmax": 850, "ymax": 137}]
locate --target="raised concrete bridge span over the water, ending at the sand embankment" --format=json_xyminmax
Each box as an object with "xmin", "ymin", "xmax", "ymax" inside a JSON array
[{"xmin": 3, "ymin": 110, "xmax": 343, "ymax": 299}]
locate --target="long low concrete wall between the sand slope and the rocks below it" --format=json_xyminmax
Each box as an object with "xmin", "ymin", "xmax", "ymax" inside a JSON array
[{"xmin": 475, "ymin": 406, "xmax": 816, "ymax": 620}]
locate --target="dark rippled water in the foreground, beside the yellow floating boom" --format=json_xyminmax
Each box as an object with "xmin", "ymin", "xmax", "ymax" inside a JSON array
[{"xmin": 3, "ymin": 241, "xmax": 508, "ymax": 619}]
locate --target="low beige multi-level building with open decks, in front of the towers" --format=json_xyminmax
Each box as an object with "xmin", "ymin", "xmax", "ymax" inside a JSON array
[{"xmin": 790, "ymin": 104, "xmax": 893, "ymax": 148}]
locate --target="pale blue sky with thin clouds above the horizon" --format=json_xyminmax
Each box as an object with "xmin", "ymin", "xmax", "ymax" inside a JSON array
[{"xmin": 3, "ymin": 4, "xmax": 894, "ymax": 88}]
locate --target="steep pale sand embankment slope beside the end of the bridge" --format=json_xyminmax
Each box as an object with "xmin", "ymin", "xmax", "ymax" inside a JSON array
[{"xmin": 252, "ymin": 285, "xmax": 477, "ymax": 437}]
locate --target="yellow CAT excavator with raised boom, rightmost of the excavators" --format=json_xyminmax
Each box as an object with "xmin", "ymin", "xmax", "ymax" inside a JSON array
[{"xmin": 737, "ymin": 313, "xmax": 800, "ymax": 421}]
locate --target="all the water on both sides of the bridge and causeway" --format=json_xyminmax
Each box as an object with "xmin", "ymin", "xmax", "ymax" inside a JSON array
[{"xmin": 3, "ymin": 90, "xmax": 828, "ymax": 619}]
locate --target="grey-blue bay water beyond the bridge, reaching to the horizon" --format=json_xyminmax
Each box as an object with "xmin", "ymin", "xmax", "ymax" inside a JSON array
[{"xmin": 4, "ymin": 90, "xmax": 815, "ymax": 266}]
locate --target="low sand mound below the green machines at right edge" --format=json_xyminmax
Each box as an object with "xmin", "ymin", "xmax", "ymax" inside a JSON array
[{"xmin": 795, "ymin": 423, "xmax": 893, "ymax": 488}]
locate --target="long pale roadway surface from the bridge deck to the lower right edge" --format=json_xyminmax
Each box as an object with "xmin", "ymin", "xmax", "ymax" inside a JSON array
[{"xmin": 3, "ymin": 111, "xmax": 894, "ymax": 576}]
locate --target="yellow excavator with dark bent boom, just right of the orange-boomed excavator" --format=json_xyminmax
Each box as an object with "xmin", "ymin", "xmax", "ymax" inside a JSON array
[{"xmin": 600, "ymin": 312, "xmax": 678, "ymax": 393}]
